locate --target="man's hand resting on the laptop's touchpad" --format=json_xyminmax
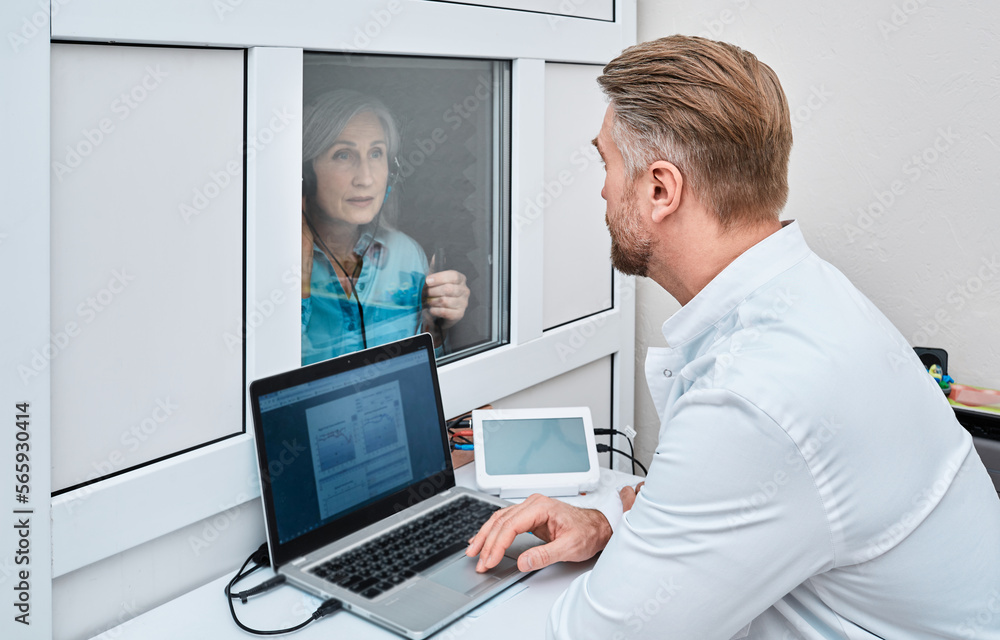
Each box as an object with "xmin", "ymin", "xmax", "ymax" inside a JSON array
[{"xmin": 465, "ymin": 493, "xmax": 611, "ymax": 572}]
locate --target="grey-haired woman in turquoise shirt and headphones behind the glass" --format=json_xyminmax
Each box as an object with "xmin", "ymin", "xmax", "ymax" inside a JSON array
[{"xmin": 302, "ymin": 89, "xmax": 469, "ymax": 365}]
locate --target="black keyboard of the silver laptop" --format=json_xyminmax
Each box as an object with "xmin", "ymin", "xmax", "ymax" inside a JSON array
[{"xmin": 309, "ymin": 496, "xmax": 500, "ymax": 599}]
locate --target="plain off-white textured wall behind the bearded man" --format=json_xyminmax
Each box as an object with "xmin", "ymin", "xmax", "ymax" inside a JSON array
[{"xmin": 636, "ymin": 0, "xmax": 1000, "ymax": 470}]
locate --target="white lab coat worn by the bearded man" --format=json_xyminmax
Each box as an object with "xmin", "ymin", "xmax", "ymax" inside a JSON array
[{"xmin": 548, "ymin": 222, "xmax": 1000, "ymax": 640}]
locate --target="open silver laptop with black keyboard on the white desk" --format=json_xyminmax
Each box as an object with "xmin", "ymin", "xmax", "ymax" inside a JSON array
[{"xmin": 250, "ymin": 334, "xmax": 541, "ymax": 639}]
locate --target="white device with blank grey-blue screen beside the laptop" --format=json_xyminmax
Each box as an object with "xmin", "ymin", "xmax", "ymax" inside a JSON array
[{"xmin": 472, "ymin": 407, "xmax": 601, "ymax": 498}]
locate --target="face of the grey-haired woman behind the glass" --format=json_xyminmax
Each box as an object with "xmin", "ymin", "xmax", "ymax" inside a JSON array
[{"xmin": 313, "ymin": 111, "xmax": 389, "ymax": 225}]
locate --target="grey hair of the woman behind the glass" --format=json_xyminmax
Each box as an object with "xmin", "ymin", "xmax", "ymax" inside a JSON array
[{"xmin": 302, "ymin": 89, "xmax": 399, "ymax": 225}]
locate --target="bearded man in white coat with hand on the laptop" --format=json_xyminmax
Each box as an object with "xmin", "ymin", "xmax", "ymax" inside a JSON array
[{"xmin": 468, "ymin": 36, "xmax": 1000, "ymax": 640}]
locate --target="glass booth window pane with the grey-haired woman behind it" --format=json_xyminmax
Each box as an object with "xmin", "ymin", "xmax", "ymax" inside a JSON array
[{"xmin": 302, "ymin": 52, "xmax": 510, "ymax": 365}]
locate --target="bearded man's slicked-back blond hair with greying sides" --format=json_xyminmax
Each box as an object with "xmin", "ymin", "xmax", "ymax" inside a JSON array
[{"xmin": 597, "ymin": 36, "xmax": 792, "ymax": 229}]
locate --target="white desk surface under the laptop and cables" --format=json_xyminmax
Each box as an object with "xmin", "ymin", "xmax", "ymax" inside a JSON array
[{"xmin": 98, "ymin": 464, "xmax": 642, "ymax": 640}]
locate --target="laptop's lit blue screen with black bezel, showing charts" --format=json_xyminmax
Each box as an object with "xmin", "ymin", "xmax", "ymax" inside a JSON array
[{"xmin": 251, "ymin": 335, "xmax": 451, "ymax": 564}]
